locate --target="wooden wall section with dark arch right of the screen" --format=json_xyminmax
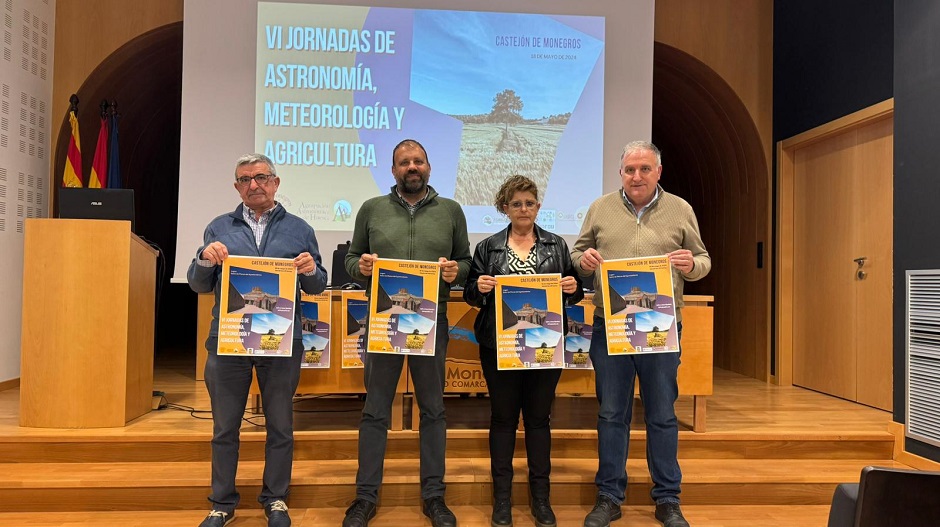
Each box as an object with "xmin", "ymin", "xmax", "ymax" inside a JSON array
[{"xmin": 653, "ymin": 0, "xmax": 773, "ymax": 379}]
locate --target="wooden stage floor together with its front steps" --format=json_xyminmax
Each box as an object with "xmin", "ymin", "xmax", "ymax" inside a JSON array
[{"xmin": 0, "ymin": 353, "xmax": 899, "ymax": 527}]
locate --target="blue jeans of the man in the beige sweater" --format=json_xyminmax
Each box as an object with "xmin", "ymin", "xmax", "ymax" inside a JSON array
[{"xmin": 590, "ymin": 316, "xmax": 682, "ymax": 504}]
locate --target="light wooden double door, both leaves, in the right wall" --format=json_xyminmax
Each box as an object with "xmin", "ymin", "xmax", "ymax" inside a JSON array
[{"xmin": 793, "ymin": 119, "xmax": 894, "ymax": 410}]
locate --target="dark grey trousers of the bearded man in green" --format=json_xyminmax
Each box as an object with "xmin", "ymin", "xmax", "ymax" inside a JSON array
[{"xmin": 356, "ymin": 312, "xmax": 449, "ymax": 503}]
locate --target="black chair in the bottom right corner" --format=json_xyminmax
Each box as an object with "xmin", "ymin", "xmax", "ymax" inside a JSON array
[{"xmin": 828, "ymin": 466, "xmax": 940, "ymax": 527}]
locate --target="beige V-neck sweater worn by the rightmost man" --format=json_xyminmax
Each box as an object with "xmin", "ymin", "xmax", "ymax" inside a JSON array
[{"xmin": 571, "ymin": 187, "xmax": 712, "ymax": 320}]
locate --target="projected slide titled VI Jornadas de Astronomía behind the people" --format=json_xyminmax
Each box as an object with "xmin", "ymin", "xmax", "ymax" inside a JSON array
[{"xmin": 255, "ymin": 2, "xmax": 604, "ymax": 234}]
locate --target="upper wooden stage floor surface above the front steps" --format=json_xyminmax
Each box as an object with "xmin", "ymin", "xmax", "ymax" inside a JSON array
[{"xmin": 0, "ymin": 350, "xmax": 891, "ymax": 437}]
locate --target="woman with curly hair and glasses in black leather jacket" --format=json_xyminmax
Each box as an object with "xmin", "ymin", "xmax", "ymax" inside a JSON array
[{"xmin": 463, "ymin": 175, "xmax": 584, "ymax": 527}]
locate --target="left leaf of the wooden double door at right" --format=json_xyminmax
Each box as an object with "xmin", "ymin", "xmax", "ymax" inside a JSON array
[{"xmin": 793, "ymin": 132, "xmax": 856, "ymax": 401}]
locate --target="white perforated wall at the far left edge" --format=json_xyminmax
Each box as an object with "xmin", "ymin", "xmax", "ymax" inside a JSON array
[{"xmin": 0, "ymin": 0, "xmax": 55, "ymax": 382}]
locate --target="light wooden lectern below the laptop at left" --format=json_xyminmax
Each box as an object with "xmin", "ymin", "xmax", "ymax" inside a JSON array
[{"xmin": 20, "ymin": 219, "xmax": 157, "ymax": 428}]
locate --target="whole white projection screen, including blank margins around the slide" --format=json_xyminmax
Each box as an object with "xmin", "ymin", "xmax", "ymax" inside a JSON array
[{"xmin": 173, "ymin": 0, "xmax": 654, "ymax": 282}]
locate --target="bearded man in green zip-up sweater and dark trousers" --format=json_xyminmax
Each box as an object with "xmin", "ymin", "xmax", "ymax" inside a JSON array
[{"xmin": 343, "ymin": 139, "xmax": 471, "ymax": 527}]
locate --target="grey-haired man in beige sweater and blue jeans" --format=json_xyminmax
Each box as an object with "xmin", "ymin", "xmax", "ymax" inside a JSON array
[{"xmin": 571, "ymin": 141, "xmax": 711, "ymax": 527}]
